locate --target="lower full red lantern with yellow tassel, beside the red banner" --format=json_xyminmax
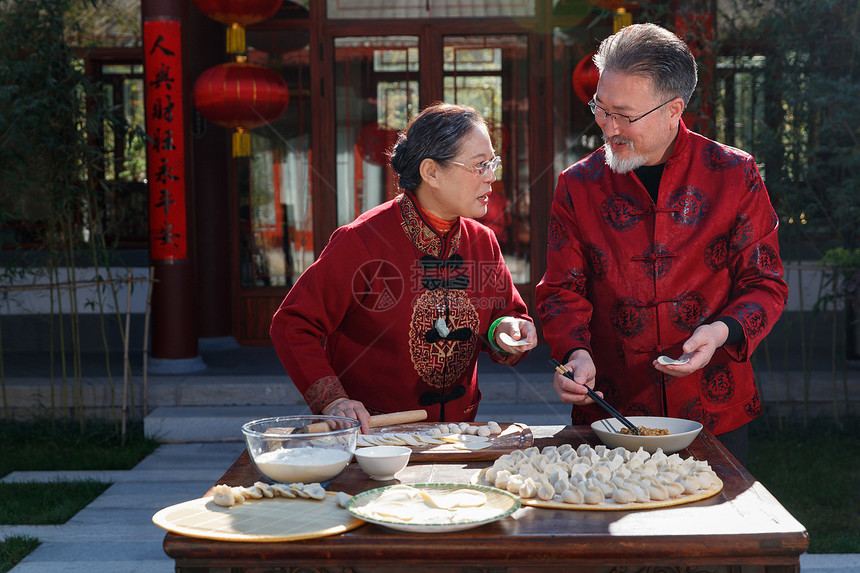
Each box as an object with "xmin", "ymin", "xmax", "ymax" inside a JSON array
[{"xmin": 194, "ymin": 59, "xmax": 290, "ymax": 157}]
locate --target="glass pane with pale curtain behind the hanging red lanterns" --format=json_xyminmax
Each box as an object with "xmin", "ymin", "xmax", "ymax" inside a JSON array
[{"xmin": 238, "ymin": 31, "xmax": 314, "ymax": 286}]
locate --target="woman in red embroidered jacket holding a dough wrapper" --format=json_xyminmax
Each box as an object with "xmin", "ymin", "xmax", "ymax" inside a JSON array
[{"xmin": 270, "ymin": 104, "xmax": 537, "ymax": 433}]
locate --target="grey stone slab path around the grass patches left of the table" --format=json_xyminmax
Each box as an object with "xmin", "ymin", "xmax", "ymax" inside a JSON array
[{"xmin": 5, "ymin": 443, "xmax": 244, "ymax": 573}]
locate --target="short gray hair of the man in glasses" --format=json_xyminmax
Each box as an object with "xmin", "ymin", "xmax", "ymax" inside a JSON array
[{"xmin": 593, "ymin": 24, "xmax": 698, "ymax": 106}]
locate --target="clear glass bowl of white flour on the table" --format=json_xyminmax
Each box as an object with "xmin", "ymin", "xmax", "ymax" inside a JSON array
[{"xmin": 242, "ymin": 416, "xmax": 361, "ymax": 483}]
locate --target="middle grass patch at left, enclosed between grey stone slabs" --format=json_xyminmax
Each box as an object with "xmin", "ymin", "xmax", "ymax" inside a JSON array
[{"xmin": 0, "ymin": 480, "xmax": 110, "ymax": 525}]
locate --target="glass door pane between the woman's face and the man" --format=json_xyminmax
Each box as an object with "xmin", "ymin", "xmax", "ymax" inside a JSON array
[{"xmin": 443, "ymin": 35, "xmax": 531, "ymax": 284}]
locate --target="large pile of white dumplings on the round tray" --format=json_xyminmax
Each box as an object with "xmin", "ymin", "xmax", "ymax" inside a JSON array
[{"xmin": 479, "ymin": 444, "xmax": 722, "ymax": 505}]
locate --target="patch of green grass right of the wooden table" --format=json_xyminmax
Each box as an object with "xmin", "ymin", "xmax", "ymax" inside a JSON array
[{"xmin": 749, "ymin": 417, "xmax": 860, "ymax": 553}]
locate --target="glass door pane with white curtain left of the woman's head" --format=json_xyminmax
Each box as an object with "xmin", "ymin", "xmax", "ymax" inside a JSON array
[{"xmin": 334, "ymin": 36, "xmax": 419, "ymax": 225}]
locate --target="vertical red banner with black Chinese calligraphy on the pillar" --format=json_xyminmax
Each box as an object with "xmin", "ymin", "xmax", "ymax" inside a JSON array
[{"xmin": 143, "ymin": 20, "xmax": 188, "ymax": 260}]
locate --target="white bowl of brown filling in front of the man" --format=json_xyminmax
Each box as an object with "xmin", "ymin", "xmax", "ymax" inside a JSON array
[{"xmin": 591, "ymin": 416, "xmax": 702, "ymax": 454}]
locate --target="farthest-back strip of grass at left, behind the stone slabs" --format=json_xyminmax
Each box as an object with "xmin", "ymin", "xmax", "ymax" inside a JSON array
[{"xmin": 0, "ymin": 420, "xmax": 158, "ymax": 477}]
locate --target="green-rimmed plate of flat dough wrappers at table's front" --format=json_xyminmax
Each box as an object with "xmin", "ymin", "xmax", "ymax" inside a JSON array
[{"xmin": 346, "ymin": 483, "xmax": 520, "ymax": 533}]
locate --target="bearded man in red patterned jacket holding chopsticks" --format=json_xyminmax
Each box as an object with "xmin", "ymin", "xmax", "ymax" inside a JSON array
[{"xmin": 536, "ymin": 24, "xmax": 788, "ymax": 463}]
